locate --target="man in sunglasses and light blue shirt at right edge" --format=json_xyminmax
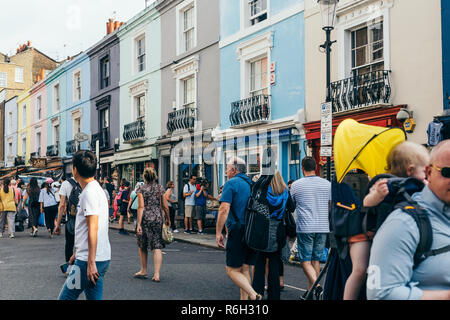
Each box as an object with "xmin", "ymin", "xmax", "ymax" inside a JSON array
[{"xmin": 367, "ymin": 140, "xmax": 450, "ymax": 300}]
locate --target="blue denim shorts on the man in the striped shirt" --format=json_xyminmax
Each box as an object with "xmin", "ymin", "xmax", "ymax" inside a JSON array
[{"xmin": 297, "ymin": 233, "xmax": 328, "ymax": 262}]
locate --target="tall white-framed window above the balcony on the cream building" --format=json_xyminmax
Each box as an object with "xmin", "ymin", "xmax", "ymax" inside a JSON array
[{"xmin": 350, "ymin": 18, "xmax": 384, "ymax": 75}]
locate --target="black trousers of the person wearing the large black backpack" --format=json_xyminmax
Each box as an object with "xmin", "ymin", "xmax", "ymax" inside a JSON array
[{"xmin": 252, "ymin": 251, "xmax": 281, "ymax": 300}]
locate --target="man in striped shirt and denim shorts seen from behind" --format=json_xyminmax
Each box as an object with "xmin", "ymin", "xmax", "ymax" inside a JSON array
[{"xmin": 291, "ymin": 157, "xmax": 331, "ymax": 297}]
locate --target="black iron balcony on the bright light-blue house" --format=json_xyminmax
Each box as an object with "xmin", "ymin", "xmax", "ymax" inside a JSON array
[{"xmin": 230, "ymin": 94, "xmax": 270, "ymax": 127}]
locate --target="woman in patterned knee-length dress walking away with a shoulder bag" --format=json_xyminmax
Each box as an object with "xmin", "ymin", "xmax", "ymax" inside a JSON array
[{"xmin": 134, "ymin": 168, "xmax": 170, "ymax": 282}]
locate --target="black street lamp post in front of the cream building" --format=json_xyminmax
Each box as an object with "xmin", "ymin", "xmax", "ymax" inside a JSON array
[{"xmin": 317, "ymin": 0, "xmax": 339, "ymax": 181}]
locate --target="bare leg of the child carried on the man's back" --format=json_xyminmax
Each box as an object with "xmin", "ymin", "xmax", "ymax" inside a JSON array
[{"xmin": 344, "ymin": 241, "xmax": 370, "ymax": 300}]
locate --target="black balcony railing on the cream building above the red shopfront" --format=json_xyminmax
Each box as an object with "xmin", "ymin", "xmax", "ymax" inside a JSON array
[{"xmin": 330, "ymin": 70, "xmax": 391, "ymax": 113}]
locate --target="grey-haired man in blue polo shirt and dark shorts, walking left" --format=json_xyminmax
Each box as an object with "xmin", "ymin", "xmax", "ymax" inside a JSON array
[{"xmin": 216, "ymin": 157, "xmax": 262, "ymax": 300}]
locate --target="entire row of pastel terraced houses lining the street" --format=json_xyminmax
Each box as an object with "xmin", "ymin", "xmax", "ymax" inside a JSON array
[{"xmin": 0, "ymin": 0, "xmax": 450, "ymax": 201}]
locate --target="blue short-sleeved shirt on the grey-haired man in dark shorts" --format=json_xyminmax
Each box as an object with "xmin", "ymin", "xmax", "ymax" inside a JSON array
[{"xmin": 220, "ymin": 173, "xmax": 252, "ymax": 228}]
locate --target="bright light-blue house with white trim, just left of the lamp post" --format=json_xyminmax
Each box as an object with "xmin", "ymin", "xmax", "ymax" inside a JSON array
[{"xmin": 215, "ymin": 0, "xmax": 305, "ymax": 184}]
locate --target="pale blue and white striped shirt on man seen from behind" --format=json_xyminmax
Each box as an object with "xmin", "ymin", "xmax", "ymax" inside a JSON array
[{"xmin": 291, "ymin": 176, "xmax": 331, "ymax": 233}]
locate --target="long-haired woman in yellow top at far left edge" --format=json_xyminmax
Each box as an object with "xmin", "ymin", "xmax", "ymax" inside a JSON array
[{"xmin": 0, "ymin": 178, "xmax": 17, "ymax": 239}]
